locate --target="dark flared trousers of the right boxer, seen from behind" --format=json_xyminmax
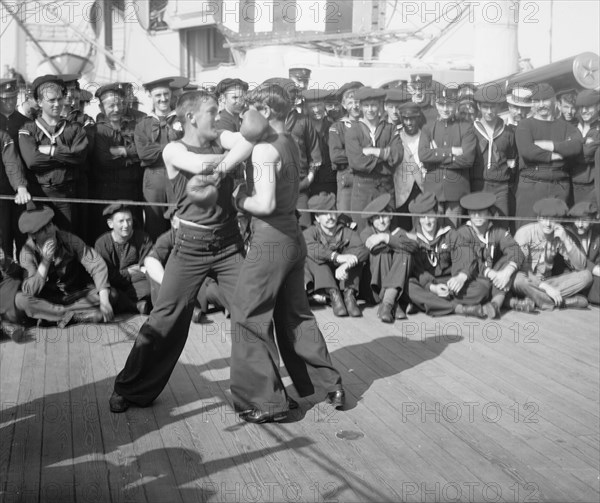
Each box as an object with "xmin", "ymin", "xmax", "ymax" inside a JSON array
[{"xmin": 231, "ymin": 219, "xmax": 342, "ymax": 413}]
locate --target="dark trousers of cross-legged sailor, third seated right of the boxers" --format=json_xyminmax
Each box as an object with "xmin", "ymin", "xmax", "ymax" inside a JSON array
[{"xmin": 408, "ymin": 276, "xmax": 491, "ymax": 316}]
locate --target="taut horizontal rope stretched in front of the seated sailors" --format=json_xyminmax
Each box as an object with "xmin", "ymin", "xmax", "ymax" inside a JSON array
[{"xmin": 0, "ymin": 195, "xmax": 600, "ymax": 224}]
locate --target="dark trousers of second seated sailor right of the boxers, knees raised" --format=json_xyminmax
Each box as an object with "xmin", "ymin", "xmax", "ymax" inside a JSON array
[{"xmin": 369, "ymin": 251, "xmax": 411, "ymax": 302}]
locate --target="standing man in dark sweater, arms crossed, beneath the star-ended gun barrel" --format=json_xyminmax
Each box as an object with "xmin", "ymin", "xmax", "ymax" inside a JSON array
[{"xmin": 516, "ymin": 83, "xmax": 582, "ymax": 225}]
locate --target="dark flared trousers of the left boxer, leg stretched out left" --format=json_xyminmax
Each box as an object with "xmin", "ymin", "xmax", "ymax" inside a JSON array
[{"xmin": 115, "ymin": 225, "xmax": 242, "ymax": 406}]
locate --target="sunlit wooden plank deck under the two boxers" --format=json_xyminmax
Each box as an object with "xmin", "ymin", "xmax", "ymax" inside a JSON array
[{"xmin": 0, "ymin": 308, "xmax": 600, "ymax": 503}]
